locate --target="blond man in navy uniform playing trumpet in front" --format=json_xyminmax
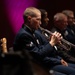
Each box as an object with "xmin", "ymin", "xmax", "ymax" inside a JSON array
[{"xmin": 13, "ymin": 7, "xmax": 75, "ymax": 75}]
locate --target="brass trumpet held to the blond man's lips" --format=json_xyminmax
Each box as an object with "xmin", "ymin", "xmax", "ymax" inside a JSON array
[{"xmin": 40, "ymin": 27, "xmax": 75, "ymax": 50}]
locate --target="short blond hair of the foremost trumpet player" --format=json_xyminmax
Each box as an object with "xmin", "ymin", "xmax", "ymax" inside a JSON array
[{"xmin": 23, "ymin": 7, "xmax": 41, "ymax": 20}]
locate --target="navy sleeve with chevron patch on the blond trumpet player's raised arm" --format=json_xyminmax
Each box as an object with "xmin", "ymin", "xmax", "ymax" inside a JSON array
[{"xmin": 20, "ymin": 35, "xmax": 54, "ymax": 57}]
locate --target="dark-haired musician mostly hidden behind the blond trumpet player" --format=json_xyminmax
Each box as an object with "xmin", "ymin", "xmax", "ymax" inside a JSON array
[{"xmin": 36, "ymin": 9, "xmax": 75, "ymax": 63}]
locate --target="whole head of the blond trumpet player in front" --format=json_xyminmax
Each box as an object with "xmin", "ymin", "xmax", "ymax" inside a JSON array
[{"xmin": 23, "ymin": 7, "xmax": 41, "ymax": 29}]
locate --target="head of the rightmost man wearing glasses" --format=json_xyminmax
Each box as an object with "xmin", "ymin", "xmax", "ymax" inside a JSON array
[{"xmin": 62, "ymin": 10, "xmax": 74, "ymax": 25}]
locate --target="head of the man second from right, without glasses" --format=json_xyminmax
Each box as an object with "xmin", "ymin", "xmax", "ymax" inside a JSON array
[{"xmin": 54, "ymin": 13, "xmax": 68, "ymax": 30}]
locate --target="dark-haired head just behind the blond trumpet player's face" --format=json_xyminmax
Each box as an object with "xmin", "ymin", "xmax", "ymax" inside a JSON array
[{"xmin": 39, "ymin": 9, "xmax": 49, "ymax": 27}]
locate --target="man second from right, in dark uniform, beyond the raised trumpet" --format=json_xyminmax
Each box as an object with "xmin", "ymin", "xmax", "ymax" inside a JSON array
[{"xmin": 52, "ymin": 13, "xmax": 75, "ymax": 57}]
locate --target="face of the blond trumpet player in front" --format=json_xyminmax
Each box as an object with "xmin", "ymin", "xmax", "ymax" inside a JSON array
[{"xmin": 30, "ymin": 13, "xmax": 41, "ymax": 30}]
